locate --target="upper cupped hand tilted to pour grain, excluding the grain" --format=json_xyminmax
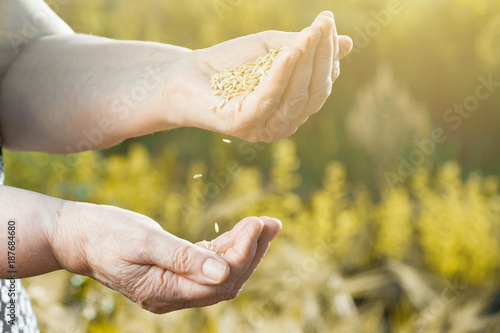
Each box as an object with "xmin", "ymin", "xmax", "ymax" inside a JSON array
[{"xmin": 170, "ymin": 11, "xmax": 352, "ymax": 142}]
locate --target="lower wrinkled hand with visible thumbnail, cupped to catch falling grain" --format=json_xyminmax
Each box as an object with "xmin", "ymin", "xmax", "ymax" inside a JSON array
[{"xmin": 48, "ymin": 202, "xmax": 281, "ymax": 313}]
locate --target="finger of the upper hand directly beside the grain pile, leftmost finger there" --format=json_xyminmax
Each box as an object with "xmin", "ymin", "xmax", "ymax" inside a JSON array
[{"xmin": 242, "ymin": 47, "xmax": 300, "ymax": 120}]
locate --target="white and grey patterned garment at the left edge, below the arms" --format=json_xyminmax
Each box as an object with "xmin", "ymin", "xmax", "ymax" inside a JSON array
[{"xmin": 0, "ymin": 139, "xmax": 40, "ymax": 333}]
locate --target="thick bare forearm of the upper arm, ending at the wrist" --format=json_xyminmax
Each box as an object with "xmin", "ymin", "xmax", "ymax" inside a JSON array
[{"xmin": 0, "ymin": 35, "xmax": 191, "ymax": 153}]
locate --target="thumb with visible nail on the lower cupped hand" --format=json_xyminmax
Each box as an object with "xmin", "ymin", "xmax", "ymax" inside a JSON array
[{"xmin": 148, "ymin": 230, "xmax": 230, "ymax": 285}]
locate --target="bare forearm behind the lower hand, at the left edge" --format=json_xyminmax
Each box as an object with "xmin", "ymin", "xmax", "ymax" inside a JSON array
[{"xmin": 0, "ymin": 186, "xmax": 63, "ymax": 278}]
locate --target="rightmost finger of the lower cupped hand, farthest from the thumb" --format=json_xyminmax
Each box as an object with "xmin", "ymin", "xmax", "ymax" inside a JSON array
[{"xmin": 230, "ymin": 217, "xmax": 283, "ymax": 293}]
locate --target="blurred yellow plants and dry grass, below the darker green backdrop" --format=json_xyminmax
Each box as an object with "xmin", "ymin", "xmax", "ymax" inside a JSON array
[{"xmin": 6, "ymin": 140, "xmax": 500, "ymax": 332}]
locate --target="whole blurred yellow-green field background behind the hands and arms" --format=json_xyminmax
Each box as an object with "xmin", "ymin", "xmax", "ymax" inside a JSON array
[{"xmin": 5, "ymin": 0, "xmax": 500, "ymax": 333}]
